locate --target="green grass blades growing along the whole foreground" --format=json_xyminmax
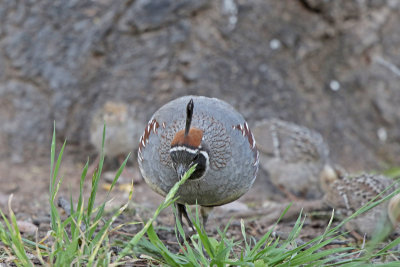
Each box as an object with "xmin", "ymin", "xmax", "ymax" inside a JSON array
[{"xmin": 0, "ymin": 123, "xmax": 400, "ymax": 267}]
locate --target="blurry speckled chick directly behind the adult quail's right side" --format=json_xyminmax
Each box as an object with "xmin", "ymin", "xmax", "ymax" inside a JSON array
[{"xmin": 254, "ymin": 119, "xmax": 329, "ymax": 199}]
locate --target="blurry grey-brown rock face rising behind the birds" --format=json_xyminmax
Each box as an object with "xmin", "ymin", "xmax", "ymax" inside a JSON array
[{"xmin": 0, "ymin": 0, "xmax": 400, "ymax": 170}]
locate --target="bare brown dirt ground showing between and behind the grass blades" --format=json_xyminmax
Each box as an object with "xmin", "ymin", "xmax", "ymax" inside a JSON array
[{"xmin": 0, "ymin": 150, "xmax": 396, "ymax": 264}]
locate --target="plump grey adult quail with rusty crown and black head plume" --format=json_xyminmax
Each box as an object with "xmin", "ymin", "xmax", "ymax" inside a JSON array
[{"xmin": 138, "ymin": 96, "xmax": 258, "ymax": 228}]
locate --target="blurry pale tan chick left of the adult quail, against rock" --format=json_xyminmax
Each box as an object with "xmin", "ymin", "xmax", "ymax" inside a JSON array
[{"xmin": 88, "ymin": 101, "xmax": 144, "ymax": 181}]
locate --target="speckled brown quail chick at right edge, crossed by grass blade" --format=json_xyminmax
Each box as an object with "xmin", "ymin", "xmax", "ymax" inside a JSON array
[{"xmin": 322, "ymin": 174, "xmax": 400, "ymax": 241}]
